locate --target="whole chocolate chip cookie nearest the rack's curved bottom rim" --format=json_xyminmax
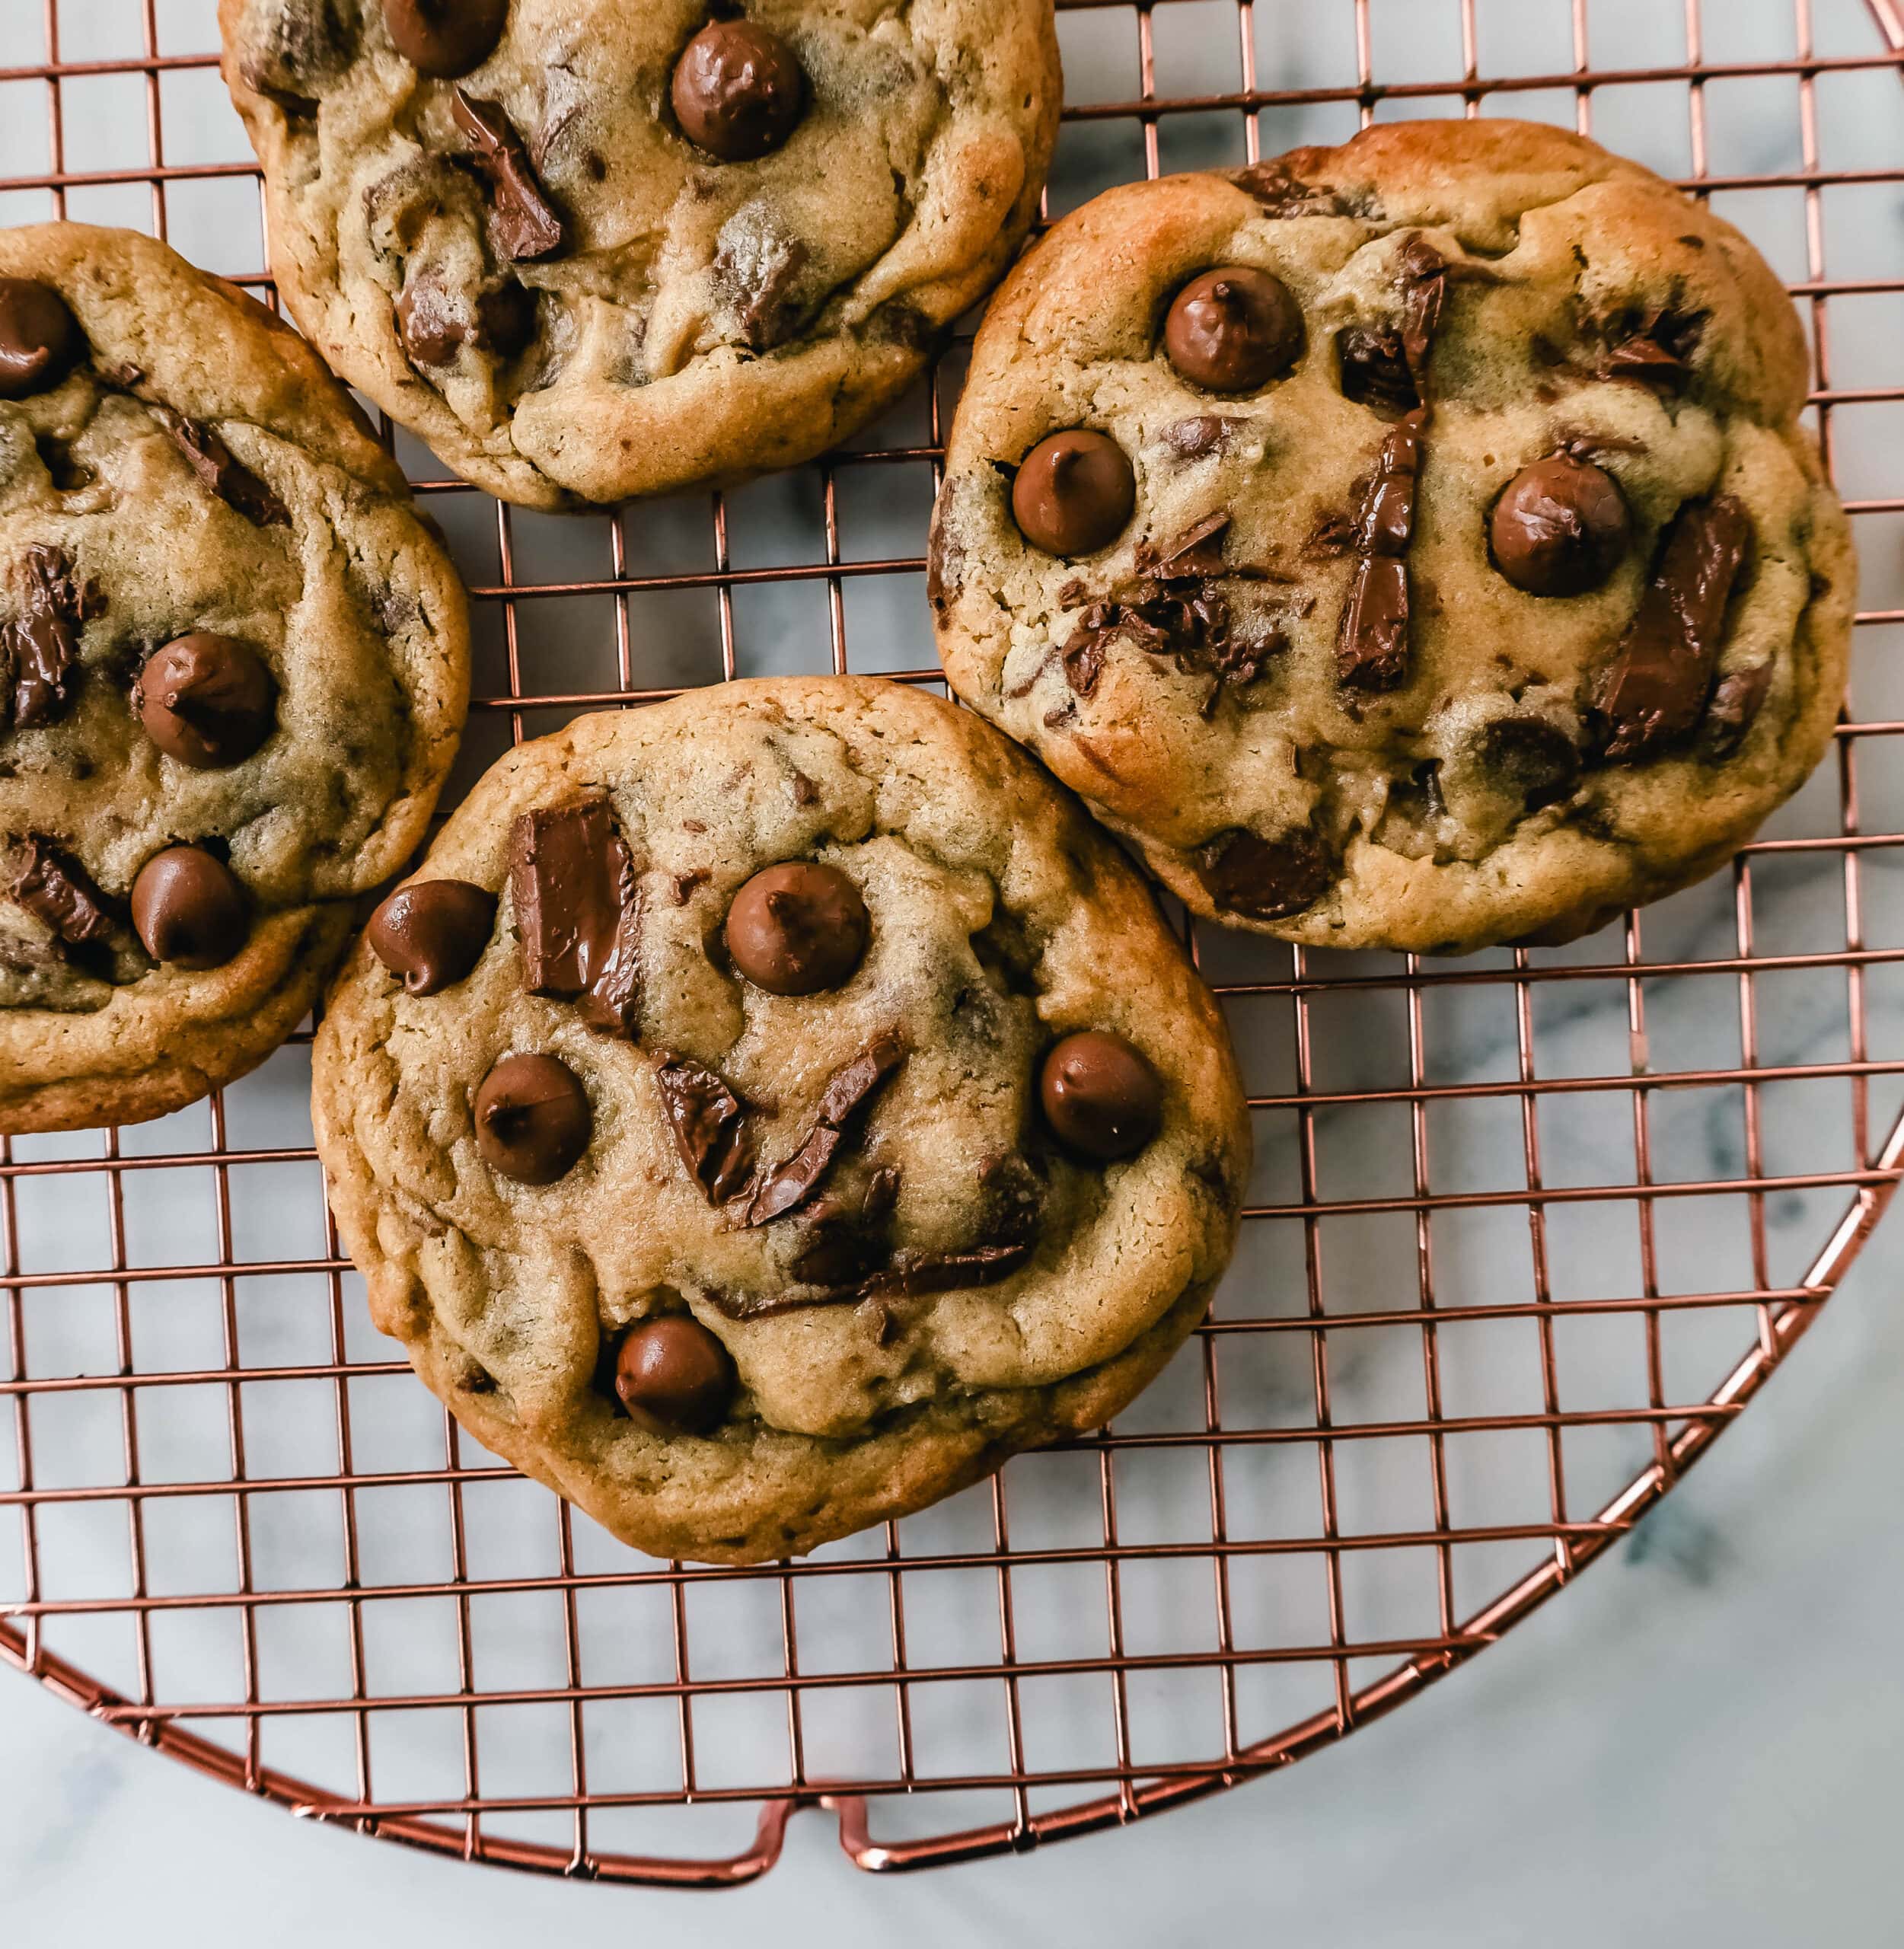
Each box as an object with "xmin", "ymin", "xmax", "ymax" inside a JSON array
[{"xmin": 314, "ymin": 676, "xmax": 1249, "ymax": 1563}]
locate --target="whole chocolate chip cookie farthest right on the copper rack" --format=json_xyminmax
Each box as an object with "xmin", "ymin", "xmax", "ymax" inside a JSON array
[{"xmin": 928, "ymin": 121, "xmax": 1853, "ymax": 951}]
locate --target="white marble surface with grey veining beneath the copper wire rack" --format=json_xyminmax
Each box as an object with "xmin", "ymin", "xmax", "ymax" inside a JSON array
[{"xmin": 11, "ymin": 0, "xmax": 1904, "ymax": 1949}]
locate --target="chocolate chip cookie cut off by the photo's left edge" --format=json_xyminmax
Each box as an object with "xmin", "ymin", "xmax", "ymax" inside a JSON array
[{"xmin": 0, "ymin": 224, "xmax": 467, "ymax": 1131}]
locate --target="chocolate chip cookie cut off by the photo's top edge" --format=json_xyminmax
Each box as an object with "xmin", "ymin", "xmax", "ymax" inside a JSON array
[{"xmin": 220, "ymin": 0, "xmax": 1060, "ymax": 507}]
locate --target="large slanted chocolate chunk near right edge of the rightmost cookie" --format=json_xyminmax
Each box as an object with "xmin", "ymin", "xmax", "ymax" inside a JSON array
[{"xmin": 1594, "ymin": 495, "xmax": 1752, "ymax": 764}]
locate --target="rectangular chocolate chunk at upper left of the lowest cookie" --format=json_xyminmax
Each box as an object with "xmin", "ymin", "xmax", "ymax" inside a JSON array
[{"xmin": 509, "ymin": 799, "xmax": 641, "ymax": 1041}]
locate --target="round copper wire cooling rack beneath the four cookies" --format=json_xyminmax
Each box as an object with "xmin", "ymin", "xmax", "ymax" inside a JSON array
[{"xmin": 0, "ymin": 0, "xmax": 1904, "ymax": 1885}]
